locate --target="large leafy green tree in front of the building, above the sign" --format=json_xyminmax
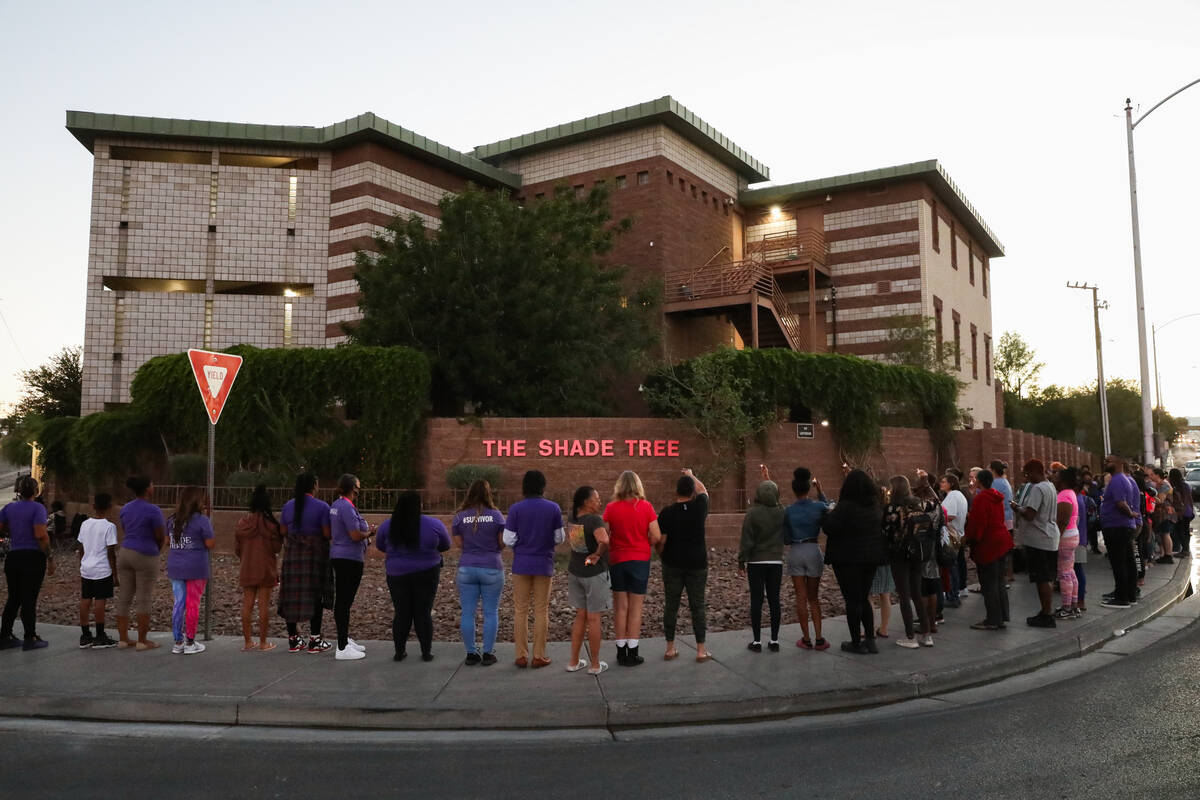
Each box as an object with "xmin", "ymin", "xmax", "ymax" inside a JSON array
[{"xmin": 348, "ymin": 187, "xmax": 662, "ymax": 415}]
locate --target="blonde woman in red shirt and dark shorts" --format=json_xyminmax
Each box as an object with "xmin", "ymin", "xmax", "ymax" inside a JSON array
[{"xmin": 604, "ymin": 469, "xmax": 662, "ymax": 667}]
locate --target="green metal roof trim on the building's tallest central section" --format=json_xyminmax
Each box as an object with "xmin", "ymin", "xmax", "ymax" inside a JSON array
[{"xmin": 474, "ymin": 95, "xmax": 770, "ymax": 182}]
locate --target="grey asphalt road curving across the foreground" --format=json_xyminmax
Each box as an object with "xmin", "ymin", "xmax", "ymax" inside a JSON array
[{"xmin": 0, "ymin": 624, "xmax": 1200, "ymax": 800}]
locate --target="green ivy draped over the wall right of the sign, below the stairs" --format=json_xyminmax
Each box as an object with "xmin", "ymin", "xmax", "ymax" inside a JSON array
[{"xmin": 644, "ymin": 348, "xmax": 959, "ymax": 458}]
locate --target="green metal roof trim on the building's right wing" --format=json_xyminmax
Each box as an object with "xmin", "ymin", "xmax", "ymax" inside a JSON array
[{"xmin": 738, "ymin": 160, "xmax": 1004, "ymax": 258}]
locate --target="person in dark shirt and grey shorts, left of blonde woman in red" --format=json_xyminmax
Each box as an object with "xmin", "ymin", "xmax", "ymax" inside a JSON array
[{"xmin": 566, "ymin": 486, "xmax": 612, "ymax": 675}]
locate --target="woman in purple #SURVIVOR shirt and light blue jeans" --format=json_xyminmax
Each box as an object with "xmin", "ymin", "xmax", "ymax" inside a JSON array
[{"xmin": 450, "ymin": 481, "xmax": 504, "ymax": 667}]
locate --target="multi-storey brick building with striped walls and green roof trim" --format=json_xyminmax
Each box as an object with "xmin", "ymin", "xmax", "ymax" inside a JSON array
[{"xmin": 67, "ymin": 97, "xmax": 1003, "ymax": 427}]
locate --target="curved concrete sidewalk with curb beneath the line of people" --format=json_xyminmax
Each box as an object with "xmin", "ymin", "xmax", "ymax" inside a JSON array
[{"xmin": 0, "ymin": 557, "xmax": 1194, "ymax": 729}]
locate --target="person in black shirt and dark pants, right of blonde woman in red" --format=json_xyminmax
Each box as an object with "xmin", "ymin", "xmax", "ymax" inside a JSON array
[{"xmin": 655, "ymin": 469, "xmax": 713, "ymax": 661}]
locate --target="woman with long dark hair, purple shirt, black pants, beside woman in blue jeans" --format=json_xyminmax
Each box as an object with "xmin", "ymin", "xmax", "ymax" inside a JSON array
[{"xmin": 376, "ymin": 492, "xmax": 450, "ymax": 661}]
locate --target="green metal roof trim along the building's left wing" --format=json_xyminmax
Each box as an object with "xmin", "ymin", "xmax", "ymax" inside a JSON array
[{"xmin": 66, "ymin": 110, "xmax": 521, "ymax": 188}]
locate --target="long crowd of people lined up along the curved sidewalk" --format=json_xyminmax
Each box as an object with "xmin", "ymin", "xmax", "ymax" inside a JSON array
[{"xmin": 0, "ymin": 456, "xmax": 1195, "ymax": 674}]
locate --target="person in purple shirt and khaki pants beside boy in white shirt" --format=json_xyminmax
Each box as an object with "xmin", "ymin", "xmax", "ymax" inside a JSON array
[{"xmin": 116, "ymin": 475, "xmax": 167, "ymax": 650}]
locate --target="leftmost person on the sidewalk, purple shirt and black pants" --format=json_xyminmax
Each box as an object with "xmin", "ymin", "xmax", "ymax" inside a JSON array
[{"xmin": 0, "ymin": 475, "xmax": 54, "ymax": 650}]
